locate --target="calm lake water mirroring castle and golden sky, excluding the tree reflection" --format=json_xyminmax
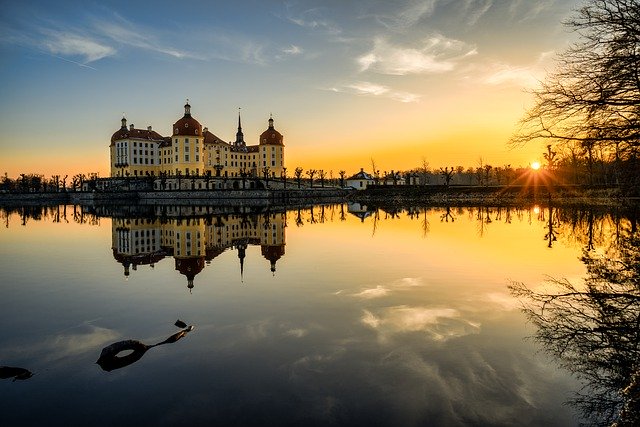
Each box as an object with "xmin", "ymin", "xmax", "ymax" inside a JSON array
[{"xmin": 0, "ymin": 205, "xmax": 629, "ymax": 426}]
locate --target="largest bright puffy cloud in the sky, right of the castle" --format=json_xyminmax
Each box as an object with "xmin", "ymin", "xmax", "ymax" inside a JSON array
[{"xmin": 356, "ymin": 34, "xmax": 477, "ymax": 75}]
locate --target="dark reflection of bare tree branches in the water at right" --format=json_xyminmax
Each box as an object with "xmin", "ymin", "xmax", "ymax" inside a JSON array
[{"xmin": 510, "ymin": 220, "xmax": 640, "ymax": 426}]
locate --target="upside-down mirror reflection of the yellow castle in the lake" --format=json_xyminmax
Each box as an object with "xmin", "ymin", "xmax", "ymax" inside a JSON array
[{"xmin": 111, "ymin": 212, "xmax": 286, "ymax": 289}]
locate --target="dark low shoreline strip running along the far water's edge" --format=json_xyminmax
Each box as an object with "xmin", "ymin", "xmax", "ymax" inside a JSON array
[{"xmin": 0, "ymin": 186, "xmax": 640, "ymax": 207}]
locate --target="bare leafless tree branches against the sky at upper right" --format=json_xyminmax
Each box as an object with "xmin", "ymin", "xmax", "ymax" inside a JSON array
[{"xmin": 510, "ymin": 0, "xmax": 640, "ymax": 192}]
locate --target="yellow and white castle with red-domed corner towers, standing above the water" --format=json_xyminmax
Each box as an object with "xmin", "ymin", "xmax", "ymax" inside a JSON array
[{"xmin": 110, "ymin": 100, "xmax": 286, "ymax": 182}]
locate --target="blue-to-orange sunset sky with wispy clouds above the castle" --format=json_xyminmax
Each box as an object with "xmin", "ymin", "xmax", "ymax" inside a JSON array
[{"xmin": 0, "ymin": 0, "xmax": 580, "ymax": 177}]
